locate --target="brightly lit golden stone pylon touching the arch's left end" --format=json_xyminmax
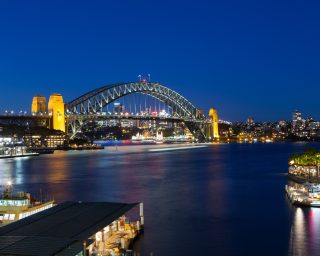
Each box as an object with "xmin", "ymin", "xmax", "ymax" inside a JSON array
[{"xmin": 48, "ymin": 93, "xmax": 66, "ymax": 132}]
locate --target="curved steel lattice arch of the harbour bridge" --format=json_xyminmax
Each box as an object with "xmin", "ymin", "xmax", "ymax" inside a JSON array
[{"xmin": 66, "ymin": 82, "xmax": 205, "ymax": 140}]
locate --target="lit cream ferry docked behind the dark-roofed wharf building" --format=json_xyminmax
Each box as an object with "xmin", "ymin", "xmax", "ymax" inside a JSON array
[{"xmin": 0, "ymin": 182, "xmax": 55, "ymax": 227}]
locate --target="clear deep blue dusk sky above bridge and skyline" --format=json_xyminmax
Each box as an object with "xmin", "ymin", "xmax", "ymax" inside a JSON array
[{"xmin": 0, "ymin": 0, "xmax": 320, "ymax": 121}]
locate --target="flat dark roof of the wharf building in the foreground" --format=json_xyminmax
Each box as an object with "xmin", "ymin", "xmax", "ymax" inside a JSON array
[{"xmin": 0, "ymin": 202, "xmax": 137, "ymax": 256}]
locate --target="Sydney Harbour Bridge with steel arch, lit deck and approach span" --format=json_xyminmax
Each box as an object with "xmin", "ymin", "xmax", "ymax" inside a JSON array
[{"xmin": 0, "ymin": 80, "xmax": 219, "ymax": 142}]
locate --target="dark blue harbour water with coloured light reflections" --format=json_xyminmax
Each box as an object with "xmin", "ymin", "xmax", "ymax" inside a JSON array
[{"xmin": 0, "ymin": 143, "xmax": 320, "ymax": 256}]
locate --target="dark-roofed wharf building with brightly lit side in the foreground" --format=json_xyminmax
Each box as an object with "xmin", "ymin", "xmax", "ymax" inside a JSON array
[{"xmin": 0, "ymin": 202, "xmax": 144, "ymax": 256}]
